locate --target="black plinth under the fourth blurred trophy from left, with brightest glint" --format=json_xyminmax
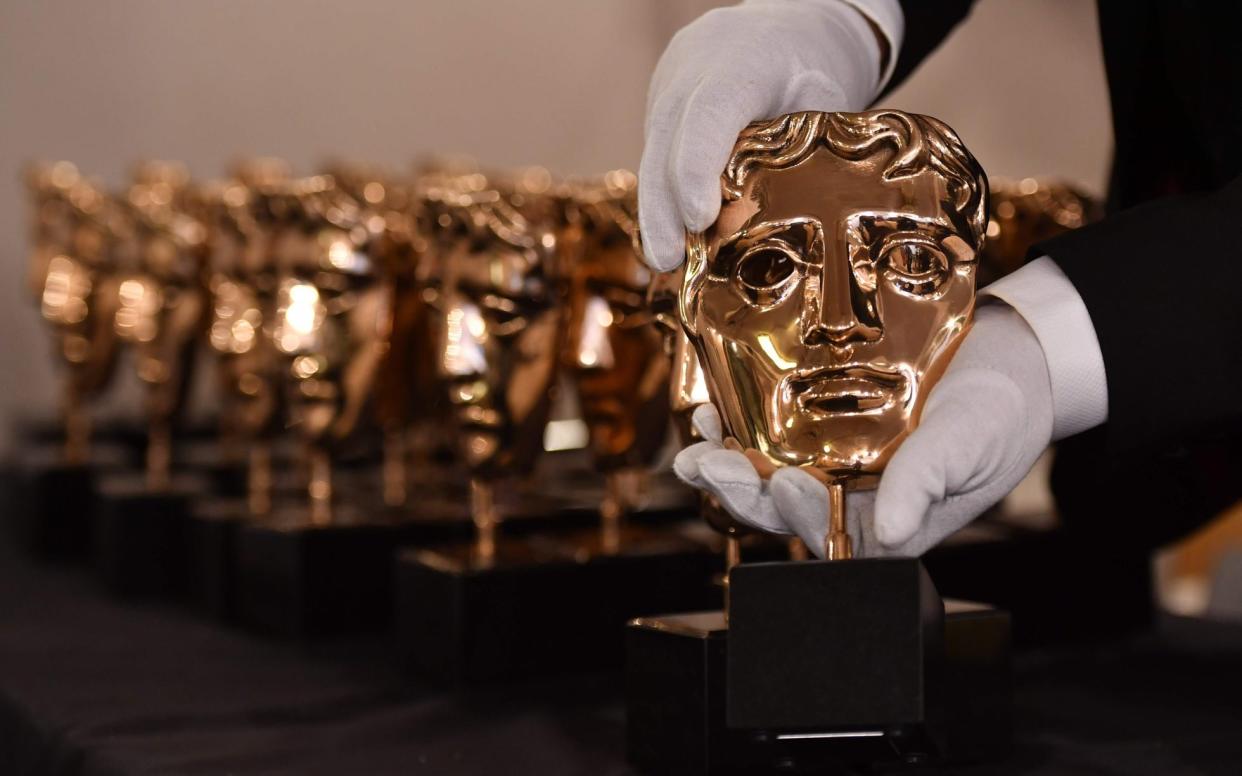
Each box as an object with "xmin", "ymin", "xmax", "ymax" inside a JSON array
[{"xmin": 233, "ymin": 508, "xmax": 432, "ymax": 638}]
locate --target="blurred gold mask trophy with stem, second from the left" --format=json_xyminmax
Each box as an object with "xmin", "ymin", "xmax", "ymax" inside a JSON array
[{"xmin": 114, "ymin": 161, "xmax": 207, "ymax": 488}]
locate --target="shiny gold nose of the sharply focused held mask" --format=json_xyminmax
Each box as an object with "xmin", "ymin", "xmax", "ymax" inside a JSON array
[{"xmin": 802, "ymin": 249, "xmax": 884, "ymax": 348}]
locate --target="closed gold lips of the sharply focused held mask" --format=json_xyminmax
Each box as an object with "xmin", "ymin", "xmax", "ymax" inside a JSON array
[{"xmin": 785, "ymin": 364, "xmax": 905, "ymax": 417}]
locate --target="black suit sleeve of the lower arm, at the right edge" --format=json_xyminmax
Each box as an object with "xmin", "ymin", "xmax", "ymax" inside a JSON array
[{"xmin": 1031, "ymin": 179, "xmax": 1242, "ymax": 458}]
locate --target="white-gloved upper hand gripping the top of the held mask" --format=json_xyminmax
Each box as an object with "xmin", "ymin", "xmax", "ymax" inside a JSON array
[{"xmin": 638, "ymin": 0, "xmax": 899, "ymax": 272}]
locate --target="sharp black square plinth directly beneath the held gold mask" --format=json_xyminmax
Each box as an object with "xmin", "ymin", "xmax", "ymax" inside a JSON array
[{"xmin": 729, "ymin": 559, "xmax": 944, "ymax": 731}]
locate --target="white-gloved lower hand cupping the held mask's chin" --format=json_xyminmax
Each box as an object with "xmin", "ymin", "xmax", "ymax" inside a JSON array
[{"xmin": 673, "ymin": 304, "xmax": 1053, "ymax": 557}]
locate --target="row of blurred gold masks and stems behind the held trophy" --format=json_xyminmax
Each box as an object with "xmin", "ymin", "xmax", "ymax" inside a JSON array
[{"xmin": 27, "ymin": 152, "xmax": 1092, "ymax": 559}]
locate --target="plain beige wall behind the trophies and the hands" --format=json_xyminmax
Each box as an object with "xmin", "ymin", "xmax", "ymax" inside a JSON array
[{"xmin": 0, "ymin": 0, "xmax": 1109, "ymax": 444}]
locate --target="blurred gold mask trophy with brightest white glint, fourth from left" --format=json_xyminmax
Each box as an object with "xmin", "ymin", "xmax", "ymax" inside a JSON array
[{"xmin": 272, "ymin": 175, "xmax": 391, "ymax": 525}]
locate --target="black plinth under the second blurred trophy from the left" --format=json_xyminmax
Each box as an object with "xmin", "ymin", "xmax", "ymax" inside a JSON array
[{"xmin": 91, "ymin": 474, "xmax": 202, "ymax": 597}]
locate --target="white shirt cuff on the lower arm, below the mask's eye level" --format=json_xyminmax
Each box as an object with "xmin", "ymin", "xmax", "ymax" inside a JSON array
[{"xmin": 980, "ymin": 256, "xmax": 1108, "ymax": 440}]
